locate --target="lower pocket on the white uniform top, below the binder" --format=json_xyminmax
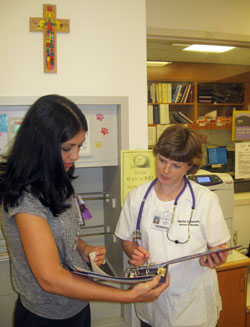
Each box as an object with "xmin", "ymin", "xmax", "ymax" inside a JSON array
[{"xmin": 169, "ymin": 289, "xmax": 207, "ymax": 327}]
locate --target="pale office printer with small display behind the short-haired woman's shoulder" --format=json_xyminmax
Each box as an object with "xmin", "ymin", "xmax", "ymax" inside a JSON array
[{"xmin": 188, "ymin": 169, "xmax": 234, "ymax": 246}]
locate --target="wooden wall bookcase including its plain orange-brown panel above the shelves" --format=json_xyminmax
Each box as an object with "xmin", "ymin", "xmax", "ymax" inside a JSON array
[{"xmin": 148, "ymin": 63, "xmax": 250, "ymax": 130}]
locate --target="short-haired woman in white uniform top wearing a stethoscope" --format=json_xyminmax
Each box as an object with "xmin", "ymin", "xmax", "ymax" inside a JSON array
[{"xmin": 115, "ymin": 124, "xmax": 230, "ymax": 327}]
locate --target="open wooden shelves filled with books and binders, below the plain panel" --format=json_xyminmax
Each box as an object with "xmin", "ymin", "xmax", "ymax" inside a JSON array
[{"xmin": 148, "ymin": 80, "xmax": 247, "ymax": 129}]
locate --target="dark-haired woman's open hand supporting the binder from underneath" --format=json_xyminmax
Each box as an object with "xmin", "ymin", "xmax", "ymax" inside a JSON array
[{"xmin": 129, "ymin": 273, "xmax": 170, "ymax": 303}]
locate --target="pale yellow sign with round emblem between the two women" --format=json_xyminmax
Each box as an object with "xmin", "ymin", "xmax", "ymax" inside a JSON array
[{"xmin": 121, "ymin": 150, "xmax": 156, "ymax": 206}]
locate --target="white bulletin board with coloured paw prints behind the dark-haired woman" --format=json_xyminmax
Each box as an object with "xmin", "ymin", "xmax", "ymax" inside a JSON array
[{"xmin": 0, "ymin": 104, "xmax": 118, "ymax": 168}]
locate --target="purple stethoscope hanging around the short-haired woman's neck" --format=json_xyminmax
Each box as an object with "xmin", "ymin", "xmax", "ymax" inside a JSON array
[{"xmin": 133, "ymin": 176, "xmax": 195, "ymax": 244}]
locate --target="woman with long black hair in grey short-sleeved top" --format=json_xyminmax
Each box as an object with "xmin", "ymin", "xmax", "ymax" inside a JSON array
[{"xmin": 0, "ymin": 95, "xmax": 168, "ymax": 327}]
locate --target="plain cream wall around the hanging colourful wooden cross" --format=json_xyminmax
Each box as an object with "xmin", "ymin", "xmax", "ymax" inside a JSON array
[{"xmin": 0, "ymin": 0, "xmax": 147, "ymax": 149}]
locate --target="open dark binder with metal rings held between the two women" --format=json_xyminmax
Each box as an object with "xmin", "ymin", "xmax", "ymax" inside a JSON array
[{"xmin": 69, "ymin": 245, "xmax": 241, "ymax": 284}]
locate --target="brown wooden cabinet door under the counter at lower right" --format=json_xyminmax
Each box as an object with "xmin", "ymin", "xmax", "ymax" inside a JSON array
[{"xmin": 218, "ymin": 267, "xmax": 248, "ymax": 327}]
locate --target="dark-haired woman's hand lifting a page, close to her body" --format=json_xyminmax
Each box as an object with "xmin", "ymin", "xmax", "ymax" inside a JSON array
[{"xmin": 78, "ymin": 240, "xmax": 106, "ymax": 266}]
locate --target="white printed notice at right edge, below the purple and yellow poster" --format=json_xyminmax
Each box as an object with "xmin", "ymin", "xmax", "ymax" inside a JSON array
[{"xmin": 235, "ymin": 142, "xmax": 250, "ymax": 179}]
